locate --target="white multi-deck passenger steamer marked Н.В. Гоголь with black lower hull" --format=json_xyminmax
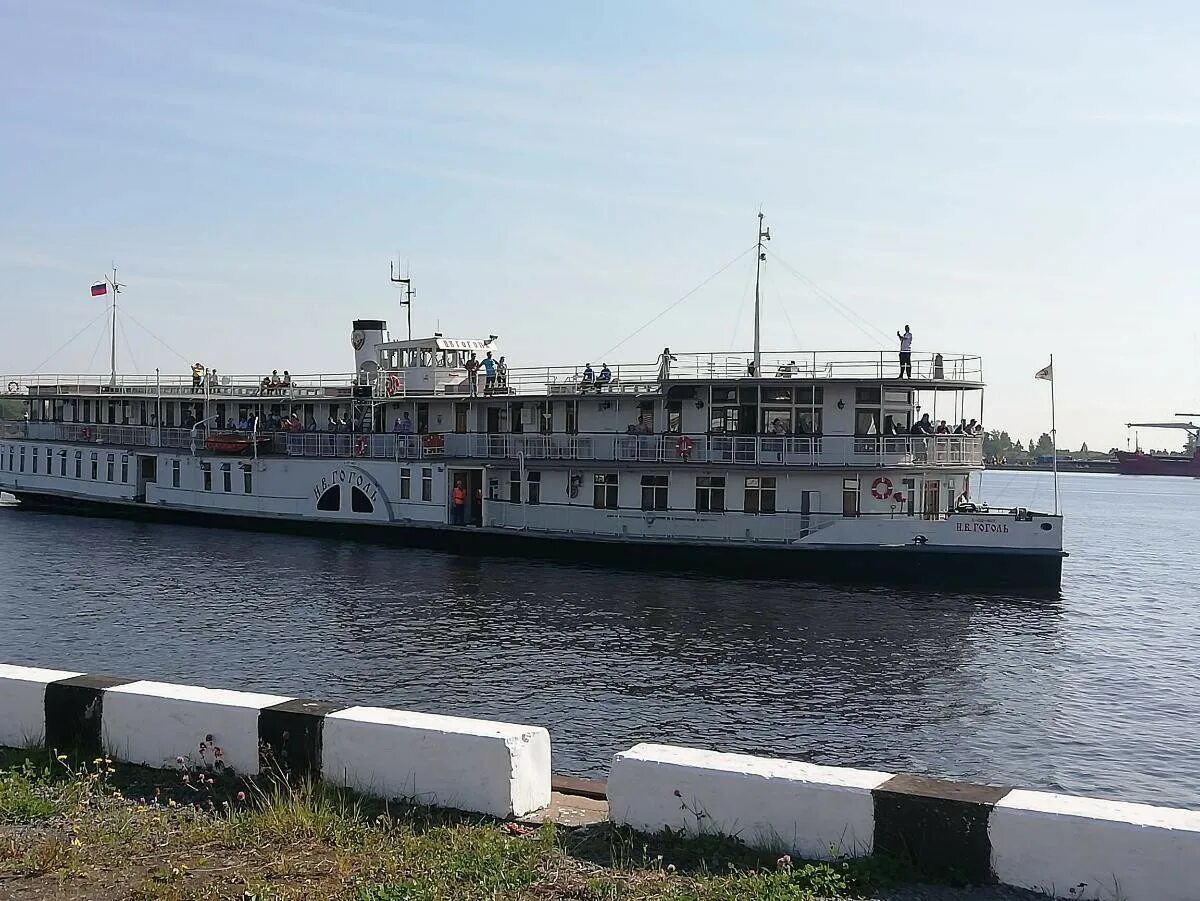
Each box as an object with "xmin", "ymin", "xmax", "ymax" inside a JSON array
[{"xmin": 0, "ymin": 221, "xmax": 1064, "ymax": 593}]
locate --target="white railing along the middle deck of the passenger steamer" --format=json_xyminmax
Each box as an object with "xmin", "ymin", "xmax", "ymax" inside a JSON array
[{"xmin": 0, "ymin": 422, "xmax": 983, "ymax": 468}]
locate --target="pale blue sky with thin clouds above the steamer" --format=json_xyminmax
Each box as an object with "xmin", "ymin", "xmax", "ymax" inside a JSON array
[{"xmin": 0, "ymin": 0, "xmax": 1200, "ymax": 450}]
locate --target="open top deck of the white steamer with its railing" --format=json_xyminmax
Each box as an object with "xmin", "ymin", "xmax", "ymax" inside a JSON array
[{"xmin": 5, "ymin": 350, "xmax": 984, "ymax": 401}]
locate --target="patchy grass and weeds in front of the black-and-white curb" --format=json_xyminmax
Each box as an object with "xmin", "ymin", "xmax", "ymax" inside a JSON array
[{"xmin": 0, "ymin": 751, "xmax": 912, "ymax": 901}]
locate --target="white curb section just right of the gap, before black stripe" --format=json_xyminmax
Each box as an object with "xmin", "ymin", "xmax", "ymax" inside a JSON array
[{"xmin": 608, "ymin": 744, "xmax": 892, "ymax": 859}]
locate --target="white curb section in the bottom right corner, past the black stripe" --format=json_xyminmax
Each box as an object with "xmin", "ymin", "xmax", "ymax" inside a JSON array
[{"xmin": 988, "ymin": 791, "xmax": 1200, "ymax": 901}]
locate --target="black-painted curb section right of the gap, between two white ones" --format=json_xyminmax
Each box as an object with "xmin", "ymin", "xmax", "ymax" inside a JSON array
[{"xmin": 871, "ymin": 775, "xmax": 1012, "ymax": 883}]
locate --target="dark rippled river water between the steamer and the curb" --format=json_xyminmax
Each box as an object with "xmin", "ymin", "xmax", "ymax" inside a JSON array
[{"xmin": 0, "ymin": 473, "xmax": 1200, "ymax": 807}]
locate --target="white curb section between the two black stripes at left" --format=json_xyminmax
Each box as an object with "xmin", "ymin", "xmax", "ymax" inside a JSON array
[{"xmin": 102, "ymin": 681, "xmax": 292, "ymax": 775}]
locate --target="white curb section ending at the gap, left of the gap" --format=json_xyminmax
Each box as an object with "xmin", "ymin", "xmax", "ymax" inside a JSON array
[{"xmin": 322, "ymin": 707, "xmax": 550, "ymax": 817}]
